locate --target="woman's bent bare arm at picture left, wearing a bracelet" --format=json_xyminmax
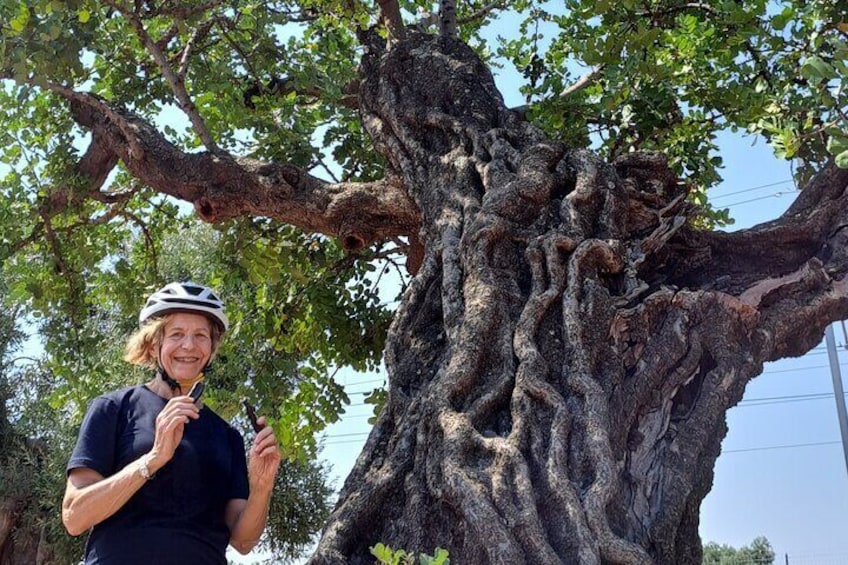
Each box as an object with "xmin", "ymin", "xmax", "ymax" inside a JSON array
[{"xmin": 62, "ymin": 396, "xmax": 198, "ymax": 536}]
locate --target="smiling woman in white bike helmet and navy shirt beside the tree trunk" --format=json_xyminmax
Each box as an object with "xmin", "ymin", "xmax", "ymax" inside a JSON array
[{"xmin": 62, "ymin": 283, "xmax": 280, "ymax": 565}]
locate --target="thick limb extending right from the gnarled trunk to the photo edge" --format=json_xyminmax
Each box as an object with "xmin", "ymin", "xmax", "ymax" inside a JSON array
[{"xmin": 638, "ymin": 165, "xmax": 848, "ymax": 361}]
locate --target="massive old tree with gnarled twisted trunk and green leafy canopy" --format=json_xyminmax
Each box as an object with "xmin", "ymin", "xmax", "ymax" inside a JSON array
[{"xmin": 0, "ymin": 0, "xmax": 848, "ymax": 564}]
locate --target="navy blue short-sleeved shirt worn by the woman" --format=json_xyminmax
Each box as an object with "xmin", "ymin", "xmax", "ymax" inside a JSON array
[{"xmin": 67, "ymin": 386, "xmax": 248, "ymax": 565}]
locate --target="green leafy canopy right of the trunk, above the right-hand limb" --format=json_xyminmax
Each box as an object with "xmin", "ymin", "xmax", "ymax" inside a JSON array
[{"xmin": 499, "ymin": 0, "xmax": 848, "ymax": 222}]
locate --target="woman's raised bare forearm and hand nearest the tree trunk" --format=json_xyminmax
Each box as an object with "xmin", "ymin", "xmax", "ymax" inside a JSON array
[{"xmin": 224, "ymin": 418, "xmax": 280, "ymax": 555}]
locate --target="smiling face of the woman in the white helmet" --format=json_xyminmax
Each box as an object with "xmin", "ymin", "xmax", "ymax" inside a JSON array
[{"xmin": 159, "ymin": 312, "xmax": 212, "ymax": 382}]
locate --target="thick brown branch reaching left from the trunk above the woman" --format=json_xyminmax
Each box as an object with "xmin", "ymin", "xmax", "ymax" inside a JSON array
[{"xmin": 64, "ymin": 93, "xmax": 419, "ymax": 250}]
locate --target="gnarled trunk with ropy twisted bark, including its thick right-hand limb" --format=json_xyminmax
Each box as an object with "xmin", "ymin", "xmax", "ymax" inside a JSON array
[{"xmin": 311, "ymin": 33, "xmax": 848, "ymax": 565}]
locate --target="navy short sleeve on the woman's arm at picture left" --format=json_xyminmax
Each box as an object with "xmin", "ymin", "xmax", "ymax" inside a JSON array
[{"xmin": 66, "ymin": 397, "xmax": 120, "ymax": 477}]
